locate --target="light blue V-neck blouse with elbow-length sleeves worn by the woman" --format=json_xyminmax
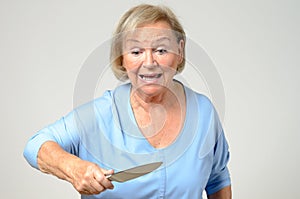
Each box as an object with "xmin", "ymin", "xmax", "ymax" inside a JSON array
[{"xmin": 24, "ymin": 84, "xmax": 231, "ymax": 199}]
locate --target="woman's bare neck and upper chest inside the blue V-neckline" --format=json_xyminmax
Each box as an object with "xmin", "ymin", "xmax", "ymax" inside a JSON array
[{"xmin": 130, "ymin": 82, "xmax": 186, "ymax": 148}]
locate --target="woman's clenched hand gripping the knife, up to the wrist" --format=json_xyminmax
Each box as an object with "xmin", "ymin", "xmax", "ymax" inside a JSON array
[{"xmin": 69, "ymin": 160, "xmax": 114, "ymax": 195}]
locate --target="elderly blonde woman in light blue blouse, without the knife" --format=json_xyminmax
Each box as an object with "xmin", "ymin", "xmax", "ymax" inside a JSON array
[{"xmin": 24, "ymin": 5, "xmax": 231, "ymax": 199}]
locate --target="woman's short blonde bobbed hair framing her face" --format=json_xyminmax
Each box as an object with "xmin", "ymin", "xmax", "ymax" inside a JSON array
[{"xmin": 110, "ymin": 4, "xmax": 186, "ymax": 81}]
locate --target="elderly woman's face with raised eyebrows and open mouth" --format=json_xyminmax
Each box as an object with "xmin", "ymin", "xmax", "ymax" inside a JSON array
[{"xmin": 123, "ymin": 21, "xmax": 183, "ymax": 96}]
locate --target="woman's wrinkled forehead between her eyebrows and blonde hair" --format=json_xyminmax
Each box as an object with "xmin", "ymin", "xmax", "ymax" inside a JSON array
[{"xmin": 123, "ymin": 28, "xmax": 177, "ymax": 47}]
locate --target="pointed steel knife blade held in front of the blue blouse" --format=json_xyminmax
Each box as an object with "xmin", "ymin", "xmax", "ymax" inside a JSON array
[{"xmin": 105, "ymin": 162, "xmax": 162, "ymax": 182}]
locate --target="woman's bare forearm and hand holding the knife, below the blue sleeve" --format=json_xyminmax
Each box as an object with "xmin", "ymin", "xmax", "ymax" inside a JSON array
[{"xmin": 37, "ymin": 141, "xmax": 113, "ymax": 194}]
